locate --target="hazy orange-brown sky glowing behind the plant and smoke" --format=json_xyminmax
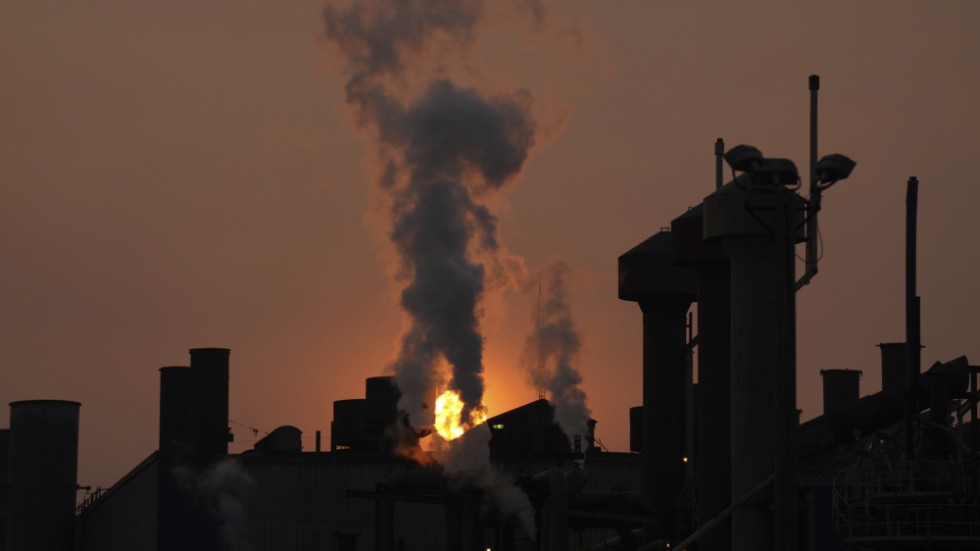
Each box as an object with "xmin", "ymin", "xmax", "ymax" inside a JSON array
[{"xmin": 0, "ymin": 0, "xmax": 980, "ymax": 486}]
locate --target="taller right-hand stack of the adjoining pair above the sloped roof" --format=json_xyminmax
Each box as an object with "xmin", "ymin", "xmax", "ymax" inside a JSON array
[{"xmin": 190, "ymin": 348, "xmax": 231, "ymax": 459}]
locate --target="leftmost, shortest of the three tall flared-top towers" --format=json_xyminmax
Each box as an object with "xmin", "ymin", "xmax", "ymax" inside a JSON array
[{"xmin": 619, "ymin": 231, "xmax": 696, "ymax": 535}]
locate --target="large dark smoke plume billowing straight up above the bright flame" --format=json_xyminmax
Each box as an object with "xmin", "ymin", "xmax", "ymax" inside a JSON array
[{"xmin": 324, "ymin": 0, "xmax": 534, "ymax": 428}]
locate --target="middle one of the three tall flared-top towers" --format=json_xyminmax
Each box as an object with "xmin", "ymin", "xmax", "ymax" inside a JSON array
[{"xmin": 670, "ymin": 205, "xmax": 732, "ymax": 551}]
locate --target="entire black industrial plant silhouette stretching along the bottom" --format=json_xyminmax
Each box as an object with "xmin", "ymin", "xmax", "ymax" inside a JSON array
[{"xmin": 0, "ymin": 76, "xmax": 980, "ymax": 551}]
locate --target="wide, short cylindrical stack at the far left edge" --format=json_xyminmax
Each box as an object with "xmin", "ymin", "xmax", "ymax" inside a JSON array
[{"xmin": 7, "ymin": 400, "xmax": 81, "ymax": 551}]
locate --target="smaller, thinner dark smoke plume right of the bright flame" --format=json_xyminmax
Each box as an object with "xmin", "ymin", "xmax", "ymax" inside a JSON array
[{"xmin": 524, "ymin": 261, "xmax": 592, "ymax": 446}]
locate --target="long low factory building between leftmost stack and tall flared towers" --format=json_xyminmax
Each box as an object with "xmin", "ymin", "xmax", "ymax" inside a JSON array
[{"xmin": 59, "ymin": 348, "xmax": 655, "ymax": 551}]
